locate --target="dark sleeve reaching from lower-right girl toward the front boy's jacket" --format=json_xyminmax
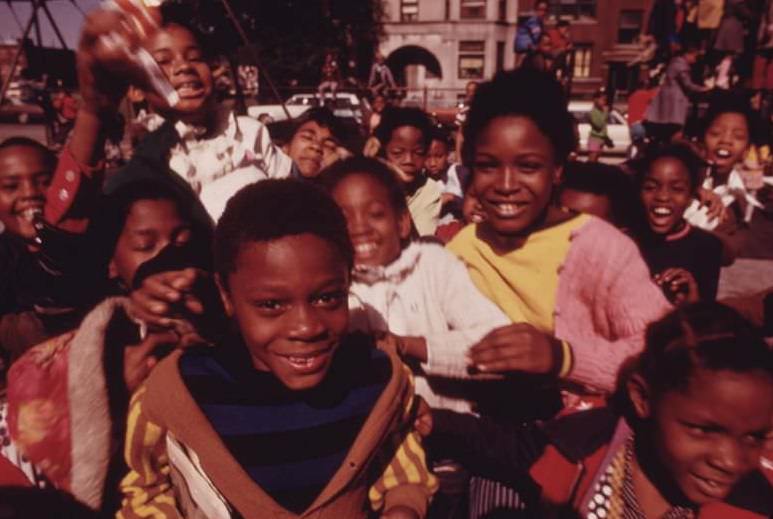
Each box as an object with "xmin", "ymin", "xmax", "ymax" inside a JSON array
[{"xmin": 428, "ymin": 409, "xmax": 547, "ymax": 486}]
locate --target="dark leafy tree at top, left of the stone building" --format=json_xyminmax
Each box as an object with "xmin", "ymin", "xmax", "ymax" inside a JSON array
[{"xmin": 165, "ymin": 0, "xmax": 383, "ymax": 96}]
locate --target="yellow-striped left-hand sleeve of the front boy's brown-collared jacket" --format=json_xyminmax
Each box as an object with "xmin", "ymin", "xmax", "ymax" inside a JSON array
[{"xmin": 116, "ymin": 387, "xmax": 182, "ymax": 519}]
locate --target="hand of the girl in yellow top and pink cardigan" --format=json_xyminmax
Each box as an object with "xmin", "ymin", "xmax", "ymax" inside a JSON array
[{"xmin": 467, "ymin": 323, "xmax": 561, "ymax": 374}]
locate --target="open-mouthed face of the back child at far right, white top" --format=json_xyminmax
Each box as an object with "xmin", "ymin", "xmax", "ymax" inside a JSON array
[{"xmin": 703, "ymin": 112, "xmax": 749, "ymax": 178}]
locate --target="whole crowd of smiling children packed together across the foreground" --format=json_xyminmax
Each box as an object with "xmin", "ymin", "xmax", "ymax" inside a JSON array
[{"xmin": 0, "ymin": 6, "xmax": 773, "ymax": 519}]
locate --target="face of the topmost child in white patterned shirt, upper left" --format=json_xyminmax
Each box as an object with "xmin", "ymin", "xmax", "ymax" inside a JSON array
[{"xmin": 146, "ymin": 25, "xmax": 214, "ymax": 122}]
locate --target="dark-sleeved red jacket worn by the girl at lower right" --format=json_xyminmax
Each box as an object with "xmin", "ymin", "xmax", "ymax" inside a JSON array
[{"xmin": 429, "ymin": 408, "xmax": 773, "ymax": 519}]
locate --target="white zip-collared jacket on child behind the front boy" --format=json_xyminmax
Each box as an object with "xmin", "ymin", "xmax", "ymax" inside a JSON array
[{"xmin": 349, "ymin": 242, "xmax": 510, "ymax": 412}]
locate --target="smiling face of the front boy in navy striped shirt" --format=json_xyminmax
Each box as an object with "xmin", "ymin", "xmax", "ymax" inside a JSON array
[{"xmin": 219, "ymin": 234, "xmax": 349, "ymax": 390}]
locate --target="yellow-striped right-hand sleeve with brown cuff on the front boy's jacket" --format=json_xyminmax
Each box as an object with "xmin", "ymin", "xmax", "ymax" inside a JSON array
[{"xmin": 368, "ymin": 365, "xmax": 438, "ymax": 517}]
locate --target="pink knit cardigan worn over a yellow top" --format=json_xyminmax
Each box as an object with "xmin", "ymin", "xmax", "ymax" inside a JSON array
[{"xmin": 554, "ymin": 218, "xmax": 672, "ymax": 391}]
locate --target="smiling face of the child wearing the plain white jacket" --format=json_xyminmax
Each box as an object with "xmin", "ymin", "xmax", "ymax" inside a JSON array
[{"xmin": 332, "ymin": 174, "xmax": 411, "ymax": 266}]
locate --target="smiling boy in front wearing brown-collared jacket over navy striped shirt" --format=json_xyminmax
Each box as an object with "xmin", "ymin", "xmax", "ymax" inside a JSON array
[{"xmin": 118, "ymin": 180, "xmax": 436, "ymax": 519}]
